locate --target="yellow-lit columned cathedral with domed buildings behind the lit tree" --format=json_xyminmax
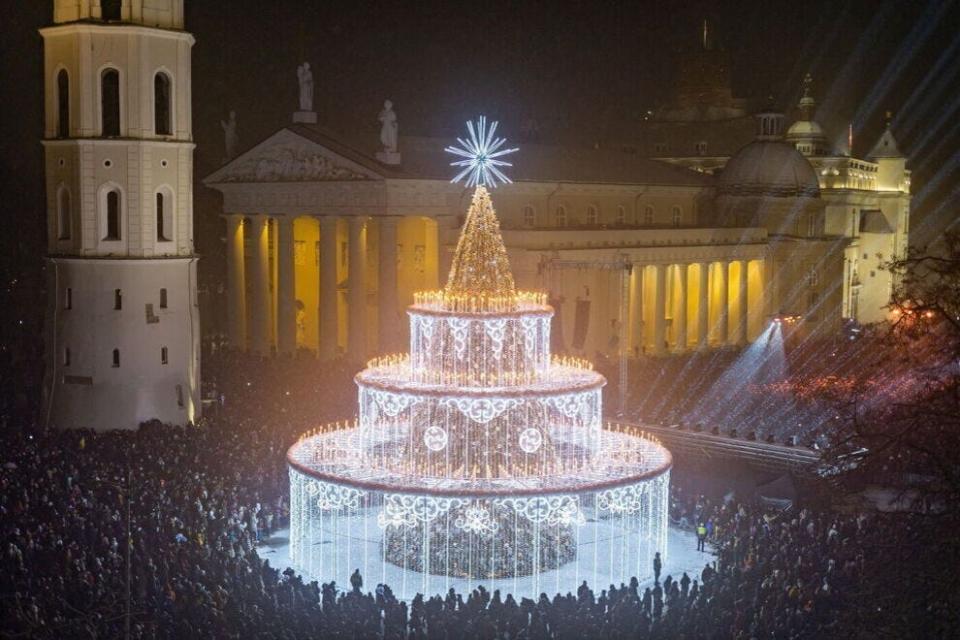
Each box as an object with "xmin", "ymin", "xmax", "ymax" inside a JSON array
[{"xmin": 204, "ymin": 25, "xmax": 910, "ymax": 362}]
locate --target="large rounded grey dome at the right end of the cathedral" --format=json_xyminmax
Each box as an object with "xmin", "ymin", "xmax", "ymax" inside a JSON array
[{"xmin": 718, "ymin": 140, "xmax": 820, "ymax": 198}]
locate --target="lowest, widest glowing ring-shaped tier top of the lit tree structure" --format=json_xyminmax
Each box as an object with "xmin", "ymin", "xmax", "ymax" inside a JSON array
[{"xmin": 287, "ymin": 428, "xmax": 673, "ymax": 499}]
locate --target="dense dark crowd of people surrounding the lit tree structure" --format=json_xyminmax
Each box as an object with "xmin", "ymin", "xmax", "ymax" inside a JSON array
[{"xmin": 0, "ymin": 353, "xmax": 944, "ymax": 640}]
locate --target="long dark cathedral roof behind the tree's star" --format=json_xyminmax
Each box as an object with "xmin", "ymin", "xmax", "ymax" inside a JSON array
[{"xmin": 214, "ymin": 124, "xmax": 712, "ymax": 187}]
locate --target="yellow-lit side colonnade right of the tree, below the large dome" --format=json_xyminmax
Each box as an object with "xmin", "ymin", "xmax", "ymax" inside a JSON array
[{"xmin": 626, "ymin": 259, "xmax": 767, "ymax": 355}]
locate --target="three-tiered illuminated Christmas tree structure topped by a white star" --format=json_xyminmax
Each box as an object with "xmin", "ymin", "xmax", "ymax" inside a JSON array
[{"xmin": 287, "ymin": 118, "xmax": 671, "ymax": 598}]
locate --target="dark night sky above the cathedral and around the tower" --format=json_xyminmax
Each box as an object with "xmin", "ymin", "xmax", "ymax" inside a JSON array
[{"xmin": 0, "ymin": 0, "xmax": 960, "ymax": 266}]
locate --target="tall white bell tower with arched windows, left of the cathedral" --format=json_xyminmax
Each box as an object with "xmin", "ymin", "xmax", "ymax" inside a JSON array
[{"xmin": 40, "ymin": 0, "xmax": 200, "ymax": 429}]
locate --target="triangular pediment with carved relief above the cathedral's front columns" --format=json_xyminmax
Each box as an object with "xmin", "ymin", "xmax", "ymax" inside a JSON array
[{"xmin": 204, "ymin": 129, "xmax": 383, "ymax": 184}]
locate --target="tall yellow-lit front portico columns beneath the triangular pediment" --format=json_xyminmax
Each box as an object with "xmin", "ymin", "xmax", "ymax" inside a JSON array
[{"xmin": 224, "ymin": 214, "xmax": 400, "ymax": 362}]
